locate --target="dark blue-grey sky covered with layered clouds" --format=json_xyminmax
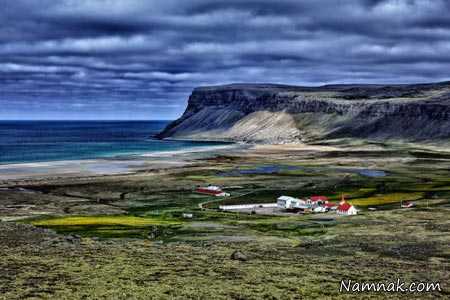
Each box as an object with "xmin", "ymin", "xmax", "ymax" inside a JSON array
[{"xmin": 0, "ymin": 0, "xmax": 450, "ymax": 120}]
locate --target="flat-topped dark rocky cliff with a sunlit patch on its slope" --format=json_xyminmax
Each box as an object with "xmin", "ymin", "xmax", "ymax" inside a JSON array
[{"xmin": 159, "ymin": 82, "xmax": 450, "ymax": 143}]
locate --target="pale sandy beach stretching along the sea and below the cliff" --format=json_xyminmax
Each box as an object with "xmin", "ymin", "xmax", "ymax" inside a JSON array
[{"xmin": 0, "ymin": 138, "xmax": 449, "ymax": 183}]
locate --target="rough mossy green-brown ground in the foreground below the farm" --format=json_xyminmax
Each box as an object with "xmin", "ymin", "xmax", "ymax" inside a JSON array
[{"xmin": 0, "ymin": 209, "xmax": 450, "ymax": 299}]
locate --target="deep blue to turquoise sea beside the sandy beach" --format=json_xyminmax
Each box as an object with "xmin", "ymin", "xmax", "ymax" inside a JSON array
[{"xmin": 0, "ymin": 121, "xmax": 223, "ymax": 164}]
